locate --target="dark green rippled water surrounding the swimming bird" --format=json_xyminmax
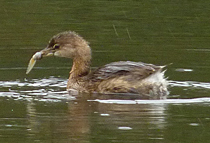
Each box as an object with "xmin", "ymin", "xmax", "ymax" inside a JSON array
[{"xmin": 0, "ymin": 0, "xmax": 210, "ymax": 143}]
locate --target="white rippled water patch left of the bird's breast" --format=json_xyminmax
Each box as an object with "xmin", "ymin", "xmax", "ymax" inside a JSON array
[{"xmin": 0, "ymin": 77, "xmax": 72, "ymax": 102}]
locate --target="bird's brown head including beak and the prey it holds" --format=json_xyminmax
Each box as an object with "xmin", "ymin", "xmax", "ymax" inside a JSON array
[{"xmin": 26, "ymin": 31, "xmax": 91, "ymax": 74}]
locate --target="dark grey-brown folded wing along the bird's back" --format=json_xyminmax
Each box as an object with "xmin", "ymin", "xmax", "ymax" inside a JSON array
[{"xmin": 90, "ymin": 61, "xmax": 164, "ymax": 82}]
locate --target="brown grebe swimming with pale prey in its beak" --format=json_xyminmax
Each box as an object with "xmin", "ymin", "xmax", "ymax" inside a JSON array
[{"xmin": 27, "ymin": 31, "xmax": 168, "ymax": 99}]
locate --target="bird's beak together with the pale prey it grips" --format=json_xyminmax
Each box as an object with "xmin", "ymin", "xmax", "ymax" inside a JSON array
[{"xmin": 26, "ymin": 48, "xmax": 54, "ymax": 74}]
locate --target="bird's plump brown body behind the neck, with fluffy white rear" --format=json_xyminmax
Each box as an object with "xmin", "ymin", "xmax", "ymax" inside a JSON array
[{"xmin": 89, "ymin": 61, "xmax": 168, "ymax": 98}]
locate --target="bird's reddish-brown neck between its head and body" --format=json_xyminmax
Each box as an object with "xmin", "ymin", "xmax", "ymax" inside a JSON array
[{"xmin": 69, "ymin": 57, "xmax": 90, "ymax": 80}]
